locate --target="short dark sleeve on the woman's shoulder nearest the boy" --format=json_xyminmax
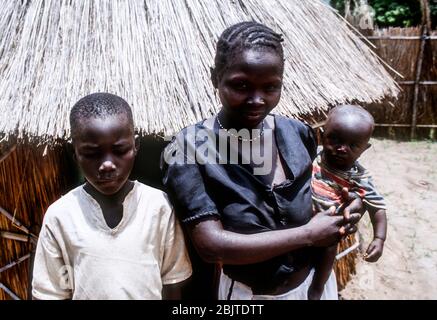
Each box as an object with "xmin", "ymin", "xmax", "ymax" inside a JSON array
[{"xmin": 161, "ymin": 133, "xmax": 220, "ymax": 223}]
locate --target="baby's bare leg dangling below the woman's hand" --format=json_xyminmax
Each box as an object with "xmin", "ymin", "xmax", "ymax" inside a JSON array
[{"xmin": 308, "ymin": 245, "xmax": 337, "ymax": 300}]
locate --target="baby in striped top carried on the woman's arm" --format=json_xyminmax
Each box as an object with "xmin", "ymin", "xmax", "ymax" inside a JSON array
[{"xmin": 308, "ymin": 105, "xmax": 387, "ymax": 299}]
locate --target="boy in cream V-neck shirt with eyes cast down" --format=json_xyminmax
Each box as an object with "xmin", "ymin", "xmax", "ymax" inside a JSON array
[{"xmin": 32, "ymin": 93, "xmax": 191, "ymax": 299}]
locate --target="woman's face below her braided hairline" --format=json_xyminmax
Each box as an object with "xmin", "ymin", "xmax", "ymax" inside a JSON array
[{"xmin": 217, "ymin": 49, "xmax": 284, "ymax": 128}]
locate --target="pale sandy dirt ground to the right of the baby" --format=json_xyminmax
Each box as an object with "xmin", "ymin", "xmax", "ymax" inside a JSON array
[{"xmin": 340, "ymin": 139, "xmax": 437, "ymax": 300}]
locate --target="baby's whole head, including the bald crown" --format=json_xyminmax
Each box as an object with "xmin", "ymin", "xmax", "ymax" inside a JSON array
[{"xmin": 322, "ymin": 105, "xmax": 375, "ymax": 170}]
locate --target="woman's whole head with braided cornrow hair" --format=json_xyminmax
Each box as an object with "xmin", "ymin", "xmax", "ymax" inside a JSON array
[{"xmin": 211, "ymin": 21, "xmax": 284, "ymax": 128}]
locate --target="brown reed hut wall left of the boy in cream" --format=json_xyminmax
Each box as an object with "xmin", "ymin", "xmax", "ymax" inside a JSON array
[{"xmin": 0, "ymin": 145, "xmax": 71, "ymax": 300}]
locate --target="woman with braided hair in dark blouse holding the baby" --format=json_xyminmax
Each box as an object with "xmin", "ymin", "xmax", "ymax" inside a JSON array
[{"xmin": 163, "ymin": 22, "xmax": 362, "ymax": 299}]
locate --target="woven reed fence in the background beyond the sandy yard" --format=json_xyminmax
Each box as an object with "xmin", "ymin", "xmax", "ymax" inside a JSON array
[{"xmin": 368, "ymin": 27, "xmax": 437, "ymax": 140}]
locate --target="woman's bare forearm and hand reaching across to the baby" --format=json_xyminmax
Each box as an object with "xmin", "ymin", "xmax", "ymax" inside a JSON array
[{"xmin": 188, "ymin": 208, "xmax": 344, "ymax": 265}]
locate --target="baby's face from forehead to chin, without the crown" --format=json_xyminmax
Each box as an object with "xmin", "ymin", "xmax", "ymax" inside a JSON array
[{"xmin": 323, "ymin": 117, "xmax": 372, "ymax": 170}]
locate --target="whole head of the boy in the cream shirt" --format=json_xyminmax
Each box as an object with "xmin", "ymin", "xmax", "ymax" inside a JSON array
[{"xmin": 70, "ymin": 93, "xmax": 138, "ymax": 195}]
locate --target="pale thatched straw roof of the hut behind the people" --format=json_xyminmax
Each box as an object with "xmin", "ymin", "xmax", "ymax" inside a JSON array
[{"xmin": 0, "ymin": 0, "xmax": 398, "ymax": 139}]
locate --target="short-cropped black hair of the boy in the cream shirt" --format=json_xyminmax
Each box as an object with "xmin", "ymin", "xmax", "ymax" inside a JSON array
[{"xmin": 70, "ymin": 92, "xmax": 134, "ymax": 139}]
